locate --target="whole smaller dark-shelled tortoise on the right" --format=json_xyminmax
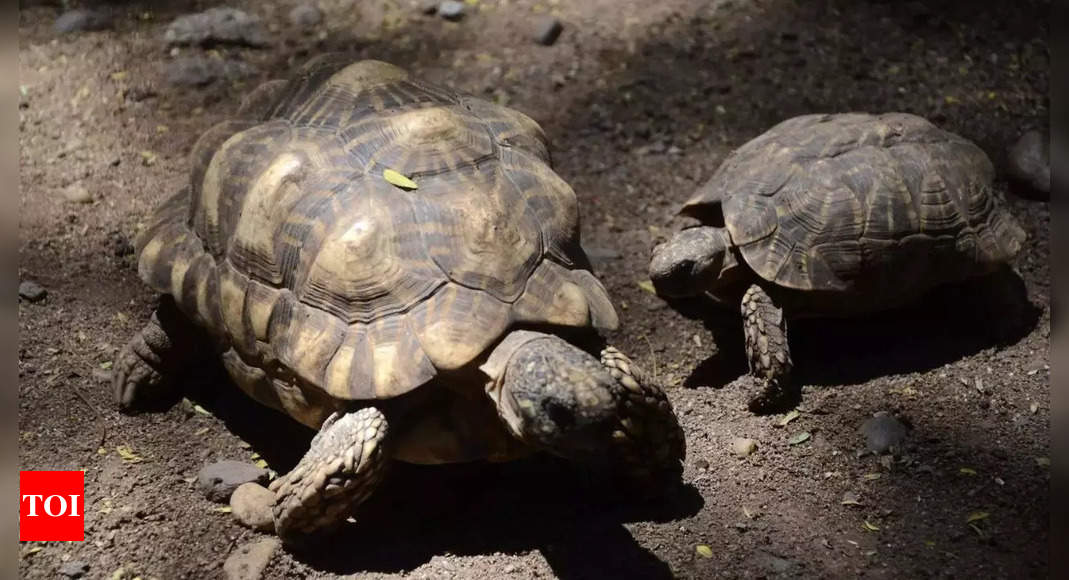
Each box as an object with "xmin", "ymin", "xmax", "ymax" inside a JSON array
[{"xmin": 650, "ymin": 113, "xmax": 1025, "ymax": 410}]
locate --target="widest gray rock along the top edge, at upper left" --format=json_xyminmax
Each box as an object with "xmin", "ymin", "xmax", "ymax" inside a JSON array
[{"xmin": 164, "ymin": 6, "xmax": 269, "ymax": 47}]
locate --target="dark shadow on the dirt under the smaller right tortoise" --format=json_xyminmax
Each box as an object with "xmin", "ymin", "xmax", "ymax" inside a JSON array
[{"xmin": 671, "ymin": 268, "xmax": 1042, "ymax": 387}]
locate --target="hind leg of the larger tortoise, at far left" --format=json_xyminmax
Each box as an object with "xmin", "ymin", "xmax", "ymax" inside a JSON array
[{"xmin": 112, "ymin": 295, "xmax": 202, "ymax": 411}]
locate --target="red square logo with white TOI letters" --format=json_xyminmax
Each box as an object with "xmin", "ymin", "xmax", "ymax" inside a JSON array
[{"xmin": 18, "ymin": 471, "xmax": 86, "ymax": 542}]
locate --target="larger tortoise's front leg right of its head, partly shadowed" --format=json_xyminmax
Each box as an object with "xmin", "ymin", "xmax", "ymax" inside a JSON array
[{"xmin": 601, "ymin": 346, "xmax": 686, "ymax": 482}]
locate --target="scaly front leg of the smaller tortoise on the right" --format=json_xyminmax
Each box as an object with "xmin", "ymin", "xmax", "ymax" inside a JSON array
[{"xmin": 742, "ymin": 284, "xmax": 797, "ymax": 412}]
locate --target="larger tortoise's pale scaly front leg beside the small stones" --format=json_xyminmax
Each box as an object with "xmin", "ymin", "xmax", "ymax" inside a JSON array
[{"xmin": 269, "ymin": 407, "xmax": 389, "ymax": 545}]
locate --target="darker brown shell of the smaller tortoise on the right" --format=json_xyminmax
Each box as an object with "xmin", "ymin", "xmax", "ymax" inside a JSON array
[{"xmin": 682, "ymin": 113, "xmax": 1024, "ymax": 299}]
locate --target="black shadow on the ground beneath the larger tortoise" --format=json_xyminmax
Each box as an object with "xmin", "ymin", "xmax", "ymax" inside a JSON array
[{"xmin": 180, "ymin": 364, "xmax": 704, "ymax": 578}]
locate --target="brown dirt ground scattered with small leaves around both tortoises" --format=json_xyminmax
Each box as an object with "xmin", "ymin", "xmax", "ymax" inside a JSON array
[{"xmin": 18, "ymin": 0, "xmax": 1050, "ymax": 579}]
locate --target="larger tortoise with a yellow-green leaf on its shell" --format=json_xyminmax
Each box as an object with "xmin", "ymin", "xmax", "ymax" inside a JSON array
[{"xmin": 114, "ymin": 56, "xmax": 685, "ymax": 544}]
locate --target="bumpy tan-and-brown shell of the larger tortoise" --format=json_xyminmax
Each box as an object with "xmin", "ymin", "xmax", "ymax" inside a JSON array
[{"xmin": 138, "ymin": 56, "xmax": 617, "ymax": 423}]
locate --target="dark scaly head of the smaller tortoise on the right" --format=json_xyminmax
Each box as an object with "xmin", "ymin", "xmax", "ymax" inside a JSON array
[{"xmin": 650, "ymin": 225, "xmax": 739, "ymax": 298}]
